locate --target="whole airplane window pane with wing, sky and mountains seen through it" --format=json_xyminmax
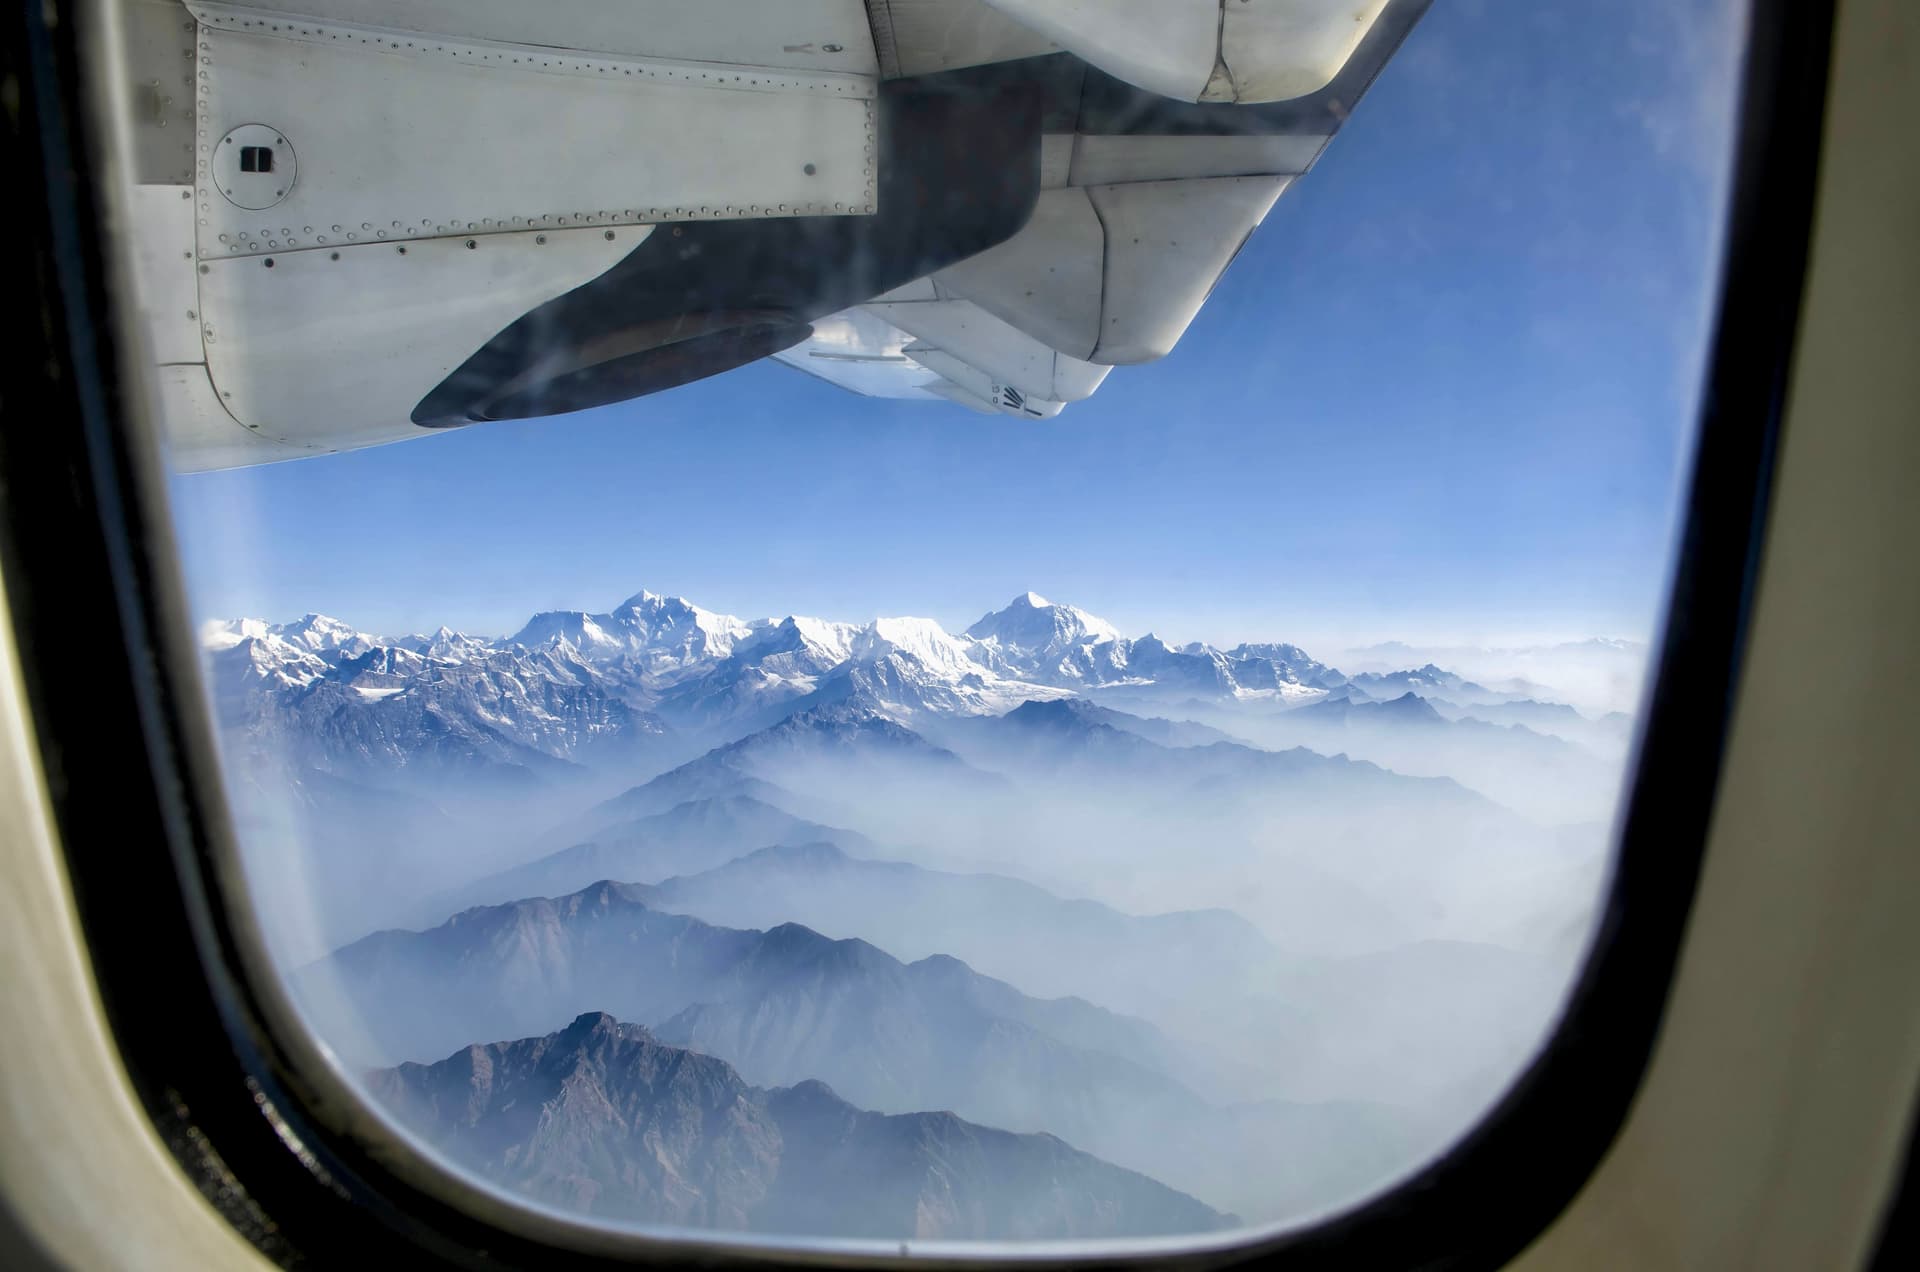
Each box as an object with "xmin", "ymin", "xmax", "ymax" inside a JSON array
[{"xmin": 119, "ymin": 0, "xmax": 1743, "ymax": 1251}]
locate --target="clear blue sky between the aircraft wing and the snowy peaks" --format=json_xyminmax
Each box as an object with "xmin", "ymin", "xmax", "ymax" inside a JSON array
[{"xmin": 173, "ymin": 0, "xmax": 1736, "ymax": 648}]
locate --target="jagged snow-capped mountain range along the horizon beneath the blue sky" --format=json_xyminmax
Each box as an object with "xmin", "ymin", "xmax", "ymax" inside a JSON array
[{"xmin": 202, "ymin": 592, "xmax": 1346, "ymax": 767}]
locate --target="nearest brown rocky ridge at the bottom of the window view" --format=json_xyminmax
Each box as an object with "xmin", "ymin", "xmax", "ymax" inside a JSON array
[{"xmin": 371, "ymin": 1013, "xmax": 1235, "ymax": 1239}]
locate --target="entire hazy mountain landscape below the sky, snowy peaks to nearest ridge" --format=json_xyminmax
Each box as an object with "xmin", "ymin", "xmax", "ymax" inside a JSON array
[{"xmin": 202, "ymin": 592, "xmax": 1645, "ymax": 1241}]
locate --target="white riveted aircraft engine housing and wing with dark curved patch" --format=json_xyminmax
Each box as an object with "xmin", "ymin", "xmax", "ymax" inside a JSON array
[{"xmin": 119, "ymin": 0, "xmax": 1427, "ymax": 471}]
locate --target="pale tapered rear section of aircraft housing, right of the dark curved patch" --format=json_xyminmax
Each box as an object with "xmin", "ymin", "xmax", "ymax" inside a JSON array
[{"xmin": 776, "ymin": 46, "xmax": 1332, "ymax": 419}]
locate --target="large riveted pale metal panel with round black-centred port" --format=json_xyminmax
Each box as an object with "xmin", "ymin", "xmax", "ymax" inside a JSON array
[{"xmin": 196, "ymin": 6, "xmax": 876, "ymax": 257}]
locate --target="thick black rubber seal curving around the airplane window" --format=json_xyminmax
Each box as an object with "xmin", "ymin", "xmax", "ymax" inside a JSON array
[{"xmin": 0, "ymin": 0, "xmax": 1834, "ymax": 1268}]
